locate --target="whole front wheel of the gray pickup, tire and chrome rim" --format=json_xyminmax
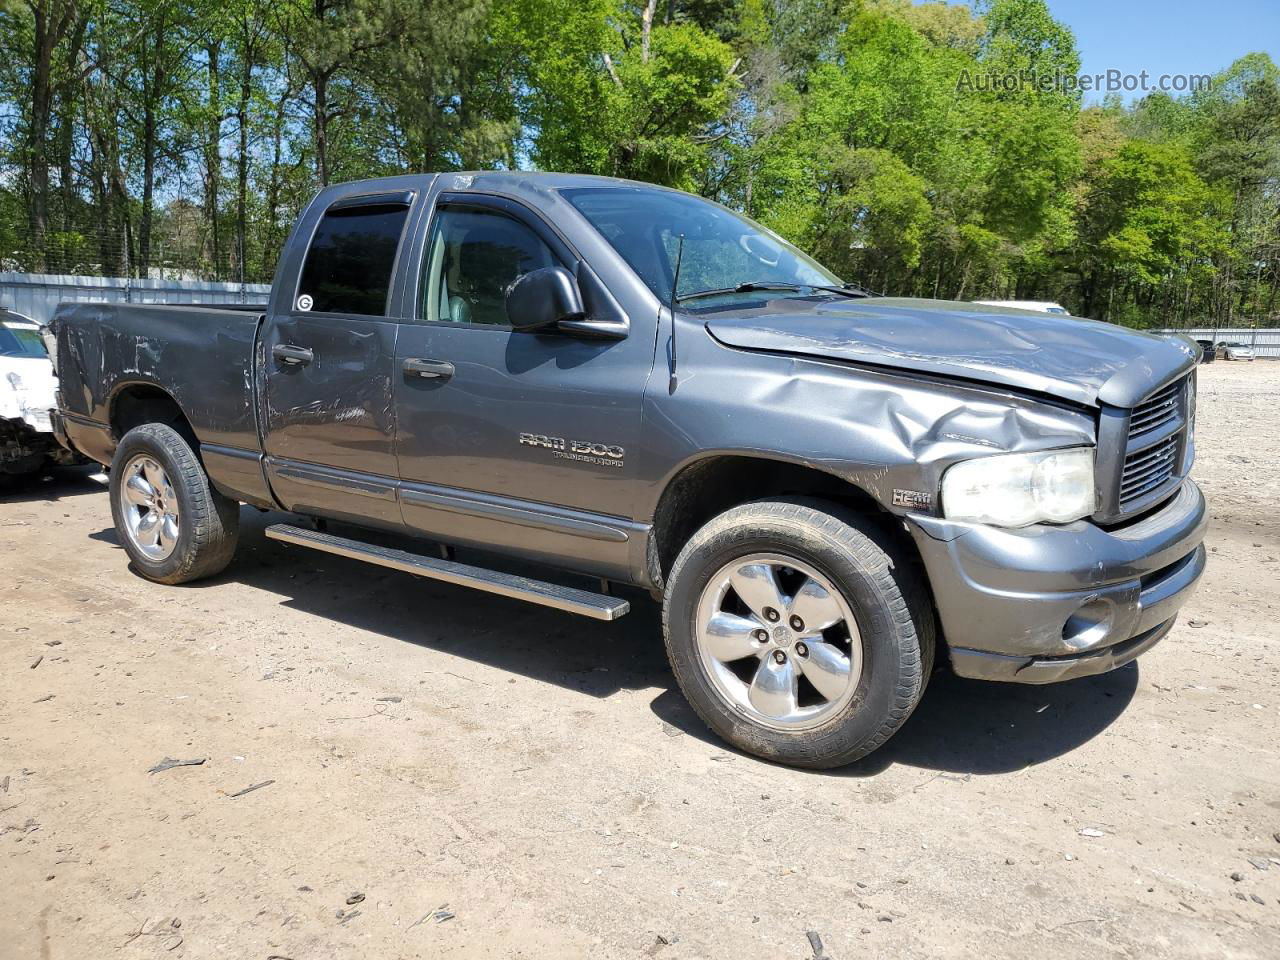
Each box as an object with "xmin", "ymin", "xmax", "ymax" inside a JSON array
[{"xmin": 663, "ymin": 499, "xmax": 934, "ymax": 769}]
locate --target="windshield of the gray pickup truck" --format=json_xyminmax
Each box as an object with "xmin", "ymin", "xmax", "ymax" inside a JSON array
[{"xmin": 561, "ymin": 187, "xmax": 841, "ymax": 302}]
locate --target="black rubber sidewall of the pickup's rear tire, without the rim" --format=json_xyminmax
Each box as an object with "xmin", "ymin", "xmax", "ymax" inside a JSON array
[{"xmin": 110, "ymin": 424, "xmax": 196, "ymax": 580}]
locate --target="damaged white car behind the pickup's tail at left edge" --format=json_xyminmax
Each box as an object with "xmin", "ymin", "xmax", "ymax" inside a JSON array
[{"xmin": 0, "ymin": 307, "xmax": 78, "ymax": 477}]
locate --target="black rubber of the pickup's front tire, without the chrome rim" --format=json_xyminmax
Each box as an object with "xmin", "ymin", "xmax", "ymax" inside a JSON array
[{"xmin": 667, "ymin": 504, "xmax": 923, "ymax": 765}]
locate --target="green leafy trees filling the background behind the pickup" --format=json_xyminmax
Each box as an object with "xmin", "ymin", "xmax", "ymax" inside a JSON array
[{"xmin": 0, "ymin": 0, "xmax": 1280, "ymax": 325}]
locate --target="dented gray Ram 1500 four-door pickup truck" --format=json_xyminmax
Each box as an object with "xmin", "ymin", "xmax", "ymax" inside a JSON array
[{"xmin": 52, "ymin": 173, "xmax": 1206, "ymax": 767}]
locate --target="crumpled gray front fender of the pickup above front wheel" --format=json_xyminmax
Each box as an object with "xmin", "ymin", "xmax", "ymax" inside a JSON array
[{"xmin": 634, "ymin": 328, "xmax": 1096, "ymax": 527}]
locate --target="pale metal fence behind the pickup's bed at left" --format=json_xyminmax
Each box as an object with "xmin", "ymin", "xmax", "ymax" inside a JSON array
[{"xmin": 0, "ymin": 271, "xmax": 271, "ymax": 324}]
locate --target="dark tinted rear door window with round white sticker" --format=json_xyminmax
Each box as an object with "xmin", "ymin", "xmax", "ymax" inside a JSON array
[{"xmin": 296, "ymin": 204, "xmax": 408, "ymax": 316}]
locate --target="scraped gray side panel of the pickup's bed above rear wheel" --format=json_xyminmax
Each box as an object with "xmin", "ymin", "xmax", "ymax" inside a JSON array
[{"xmin": 50, "ymin": 303, "xmax": 270, "ymax": 504}]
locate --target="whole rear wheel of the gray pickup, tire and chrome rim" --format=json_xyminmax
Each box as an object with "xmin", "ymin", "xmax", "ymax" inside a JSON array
[{"xmin": 110, "ymin": 424, "xmax": 239, "ymax": 584}]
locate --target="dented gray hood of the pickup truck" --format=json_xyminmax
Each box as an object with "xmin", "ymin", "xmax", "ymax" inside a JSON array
[{"xmin": 704, "ymin": 297, "xmax": 1196, "ymax": 407}]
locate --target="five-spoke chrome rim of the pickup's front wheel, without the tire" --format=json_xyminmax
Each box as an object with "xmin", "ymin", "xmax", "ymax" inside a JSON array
[{"xmin": 696, "ymin": 553, "xmax": 863, "ymax": 731}]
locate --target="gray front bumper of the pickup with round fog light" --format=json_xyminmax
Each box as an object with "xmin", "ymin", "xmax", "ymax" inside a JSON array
[{"xmin": 908, "ymin": 480, "xmax": 1208, "ymax": 684}]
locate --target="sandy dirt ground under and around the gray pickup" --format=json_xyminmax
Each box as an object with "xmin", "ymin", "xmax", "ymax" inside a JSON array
[{"xmin": 0, "ymin": 362, "xmax": 1280, "ymax": 960}]
